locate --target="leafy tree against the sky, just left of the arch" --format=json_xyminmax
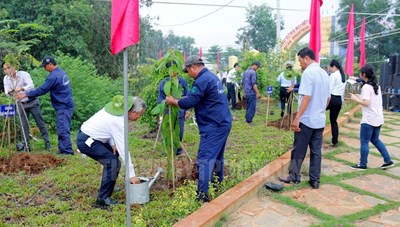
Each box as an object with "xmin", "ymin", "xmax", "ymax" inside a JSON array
[{"xmin": 236, "ymin": 4, "xmax": 284, "ymax": 53}]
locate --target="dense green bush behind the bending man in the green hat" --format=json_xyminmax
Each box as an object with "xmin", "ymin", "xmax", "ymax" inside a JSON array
[{"xmin": 30, "ymin": 53, "xmax": 123, "ymax": 130}]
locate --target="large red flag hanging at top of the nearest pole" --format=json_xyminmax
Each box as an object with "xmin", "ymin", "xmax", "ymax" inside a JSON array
[{"xmin": 111, "ymin": 0, "xmax": 140, "ymax": 55}]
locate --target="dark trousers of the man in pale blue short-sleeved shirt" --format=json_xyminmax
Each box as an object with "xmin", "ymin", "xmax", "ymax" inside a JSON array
[{"xmin": 289, "ymin": 123, "xmax": 324, "ymax": 182}]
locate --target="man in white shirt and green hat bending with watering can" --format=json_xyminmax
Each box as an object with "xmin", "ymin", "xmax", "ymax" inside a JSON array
[{"xmin": 76, "ymin": 95, "xmax": 146, "ymax": 207}]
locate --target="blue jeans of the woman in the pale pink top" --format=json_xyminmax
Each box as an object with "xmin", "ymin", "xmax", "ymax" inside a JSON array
[{"xmin": 360, "ymin": 123, "xmax": 391, "ymax": 166}]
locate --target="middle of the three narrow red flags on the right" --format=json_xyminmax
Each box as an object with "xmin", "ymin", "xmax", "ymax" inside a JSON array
[{"xmin": 345, "ymin": 4, "xmax": 356, "ymax": 76}]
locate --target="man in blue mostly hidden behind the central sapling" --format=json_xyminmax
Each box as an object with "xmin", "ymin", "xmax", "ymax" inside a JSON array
[{"xmin": 157, "ymin": 61, "xmax": 190, "ymax": 155}]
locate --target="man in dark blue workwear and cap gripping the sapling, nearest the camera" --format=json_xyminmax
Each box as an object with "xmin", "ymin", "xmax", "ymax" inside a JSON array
[{"xmin": 165, "ymin": 55, "xmax": 232, "ymax": 202}]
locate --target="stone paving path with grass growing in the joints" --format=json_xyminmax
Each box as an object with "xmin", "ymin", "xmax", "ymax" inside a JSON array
[{"xmin": 223, "ymin": 112, "xmax": 400, "ymax": 227}]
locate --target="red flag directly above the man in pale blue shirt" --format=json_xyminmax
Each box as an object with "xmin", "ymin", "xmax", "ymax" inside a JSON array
[{"xmin": 309, "ymin": 0, "xmax": 323, "ymax": 62}]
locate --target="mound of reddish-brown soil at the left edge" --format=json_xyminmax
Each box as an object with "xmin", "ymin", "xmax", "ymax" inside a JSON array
[{"xmin": 0, "ymin": 153, "xmax": 65, "ymax": 174}]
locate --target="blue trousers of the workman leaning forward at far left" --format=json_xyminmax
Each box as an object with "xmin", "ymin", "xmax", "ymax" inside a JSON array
[{"xmin": 56, "ymin": 108, "xmax": 74, "ymax": 154}]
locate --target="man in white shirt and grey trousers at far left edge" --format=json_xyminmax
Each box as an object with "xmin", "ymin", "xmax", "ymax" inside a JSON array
[{"xmin": 2, "ymin": 62, "xmax": 51, "ymax": 151}]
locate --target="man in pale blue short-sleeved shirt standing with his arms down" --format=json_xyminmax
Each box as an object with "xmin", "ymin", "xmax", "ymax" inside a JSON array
[{"xmin": 279, "ymin": 47, "xmax": 330, "ymax": 189}]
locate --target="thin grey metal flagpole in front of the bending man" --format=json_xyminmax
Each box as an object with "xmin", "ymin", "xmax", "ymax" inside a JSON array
[{"xmin": 123, "ymin": 48, "xmax": 131, "ymax": 227}]
